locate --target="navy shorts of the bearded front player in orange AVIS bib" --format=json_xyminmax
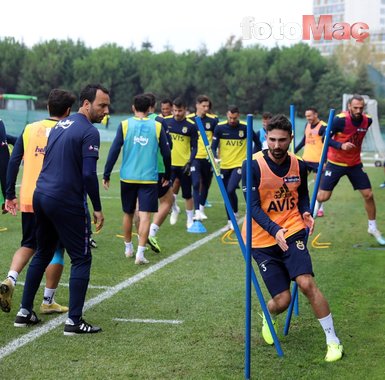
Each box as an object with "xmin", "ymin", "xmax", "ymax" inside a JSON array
[{"xmin": 252, "ymin": 230, "xmax": 314, "ymax": 297}]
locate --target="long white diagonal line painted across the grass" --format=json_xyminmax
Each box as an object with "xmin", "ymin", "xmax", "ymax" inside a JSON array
[{"xmin": 0, "ymin": 224, "xmax": 224, "ymax": 360}]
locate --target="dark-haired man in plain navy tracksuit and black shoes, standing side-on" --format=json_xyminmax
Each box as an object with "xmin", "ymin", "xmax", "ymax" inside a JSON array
[{"xmin": 14, "ymin": 85, "xmax": 110, "ymax": 335}]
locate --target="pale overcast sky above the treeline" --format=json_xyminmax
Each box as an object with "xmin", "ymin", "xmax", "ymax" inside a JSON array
[{"xmin": 0, "ymin": 0, "xmax": 312, "ymax": 52}]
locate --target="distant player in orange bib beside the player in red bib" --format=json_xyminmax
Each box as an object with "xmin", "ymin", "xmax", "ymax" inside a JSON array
[{"xmin": 294, "ymin": 107, "xmax": 327, "ymax": 217}]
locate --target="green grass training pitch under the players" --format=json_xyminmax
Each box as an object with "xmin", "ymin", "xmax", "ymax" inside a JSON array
[{"xmin": 0, "ymin": 144, "xmax": 385, "ymax": 379}]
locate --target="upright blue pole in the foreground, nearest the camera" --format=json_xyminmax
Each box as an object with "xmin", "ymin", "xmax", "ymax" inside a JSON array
[{"xmin": 244, "ymin": 115, "xmax": 253, "ymax": 379}]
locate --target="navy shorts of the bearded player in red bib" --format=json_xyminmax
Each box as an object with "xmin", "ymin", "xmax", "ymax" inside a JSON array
[{"xmin": 320, "ymin": 162, "xmax": 372, "ymax": 191}]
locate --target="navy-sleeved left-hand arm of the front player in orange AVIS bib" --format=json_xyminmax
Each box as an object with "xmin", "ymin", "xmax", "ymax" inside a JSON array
[{"xmin": 242, "ymin": 160, "xmax": 281, "ymax": 237}]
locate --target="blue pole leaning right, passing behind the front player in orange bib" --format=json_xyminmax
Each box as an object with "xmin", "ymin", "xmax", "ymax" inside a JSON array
[{"xmin": 283, "ymin": 108, "xmax": 336, "ymax": 335}]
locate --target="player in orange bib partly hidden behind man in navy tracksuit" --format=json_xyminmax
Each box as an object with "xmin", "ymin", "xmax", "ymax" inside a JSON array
[{"xmin": 0, "ymin": 89, "xmax": 75, "ymax": 314}]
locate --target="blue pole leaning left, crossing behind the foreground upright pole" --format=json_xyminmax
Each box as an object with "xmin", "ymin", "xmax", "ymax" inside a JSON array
[{"xmin": 195, "ymin": 115, "xmax": 283, "ymax": 356}]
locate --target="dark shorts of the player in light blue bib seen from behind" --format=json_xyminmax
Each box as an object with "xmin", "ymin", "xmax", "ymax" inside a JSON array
[{"xmin": 120, "ymin": 181, "xmax": 158, "ymax": 214}]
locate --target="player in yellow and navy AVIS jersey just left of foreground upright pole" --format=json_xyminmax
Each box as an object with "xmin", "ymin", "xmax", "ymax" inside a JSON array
[{"xmin": 211, "ymin": 105, "xmax": 257, "ymax": 230}]
